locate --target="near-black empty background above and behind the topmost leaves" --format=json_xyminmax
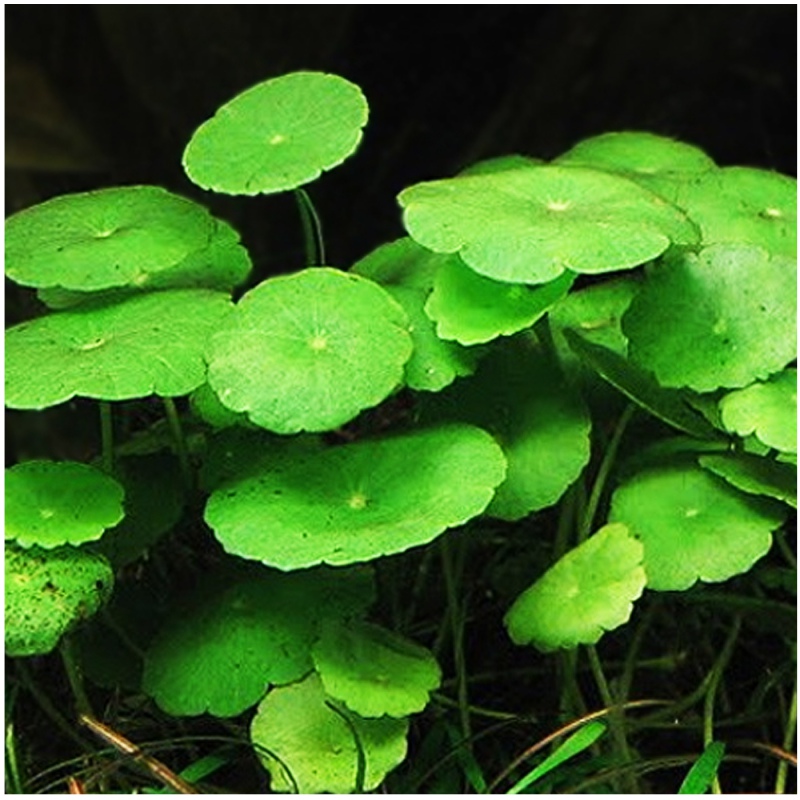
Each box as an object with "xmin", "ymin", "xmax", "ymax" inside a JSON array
[{"xmin": 5, "ymin": 4, "xmax": 797, "ymax": 275}]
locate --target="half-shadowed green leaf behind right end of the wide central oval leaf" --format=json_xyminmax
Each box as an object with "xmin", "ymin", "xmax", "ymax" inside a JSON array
[{"xmin": 428, "ymin": 335, "xmax": 591, "ymax": 520}]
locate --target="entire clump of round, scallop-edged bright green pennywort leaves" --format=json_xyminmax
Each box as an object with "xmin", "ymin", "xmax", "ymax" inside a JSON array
[{"xmin": 6, "ymin": 72, "xmax": 797, "ymax": 793}]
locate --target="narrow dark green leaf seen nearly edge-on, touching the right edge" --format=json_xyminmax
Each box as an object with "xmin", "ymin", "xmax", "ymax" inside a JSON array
[{"xmin": 697, "ymin": 453, "xmax": 797, "ymax": 508}]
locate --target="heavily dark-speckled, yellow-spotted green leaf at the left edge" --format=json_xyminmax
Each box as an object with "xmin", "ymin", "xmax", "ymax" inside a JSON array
[{"xmin": 5, "ymin": 543, "xmax": 114, "ymax": 657}]
